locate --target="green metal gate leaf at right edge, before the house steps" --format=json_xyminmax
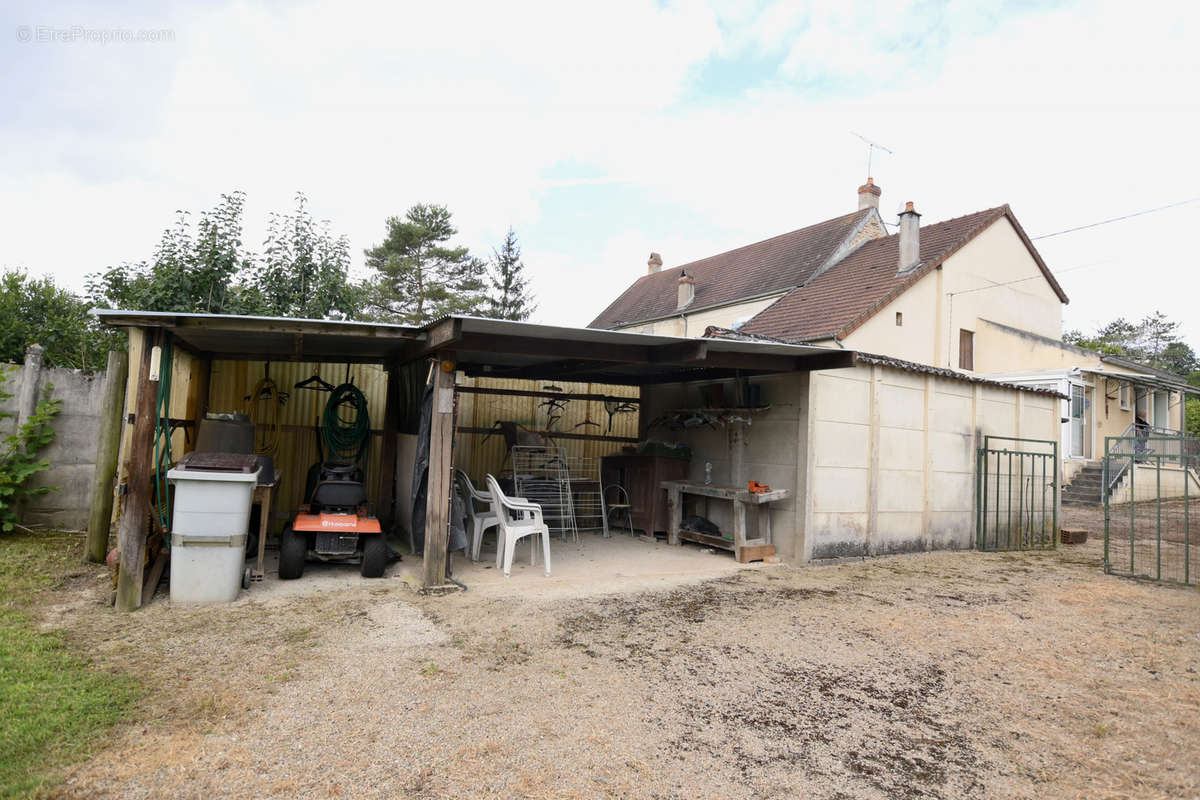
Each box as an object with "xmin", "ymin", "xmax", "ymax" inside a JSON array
[{"xmin": 1104, "ymin": 427, "xmax": 1200, "ymax": 585}]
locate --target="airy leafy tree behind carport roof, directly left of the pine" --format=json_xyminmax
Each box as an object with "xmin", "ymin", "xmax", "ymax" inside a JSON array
[{"xmin": 242, "ymin": 192, "xmax": 359, "ymax": 319}]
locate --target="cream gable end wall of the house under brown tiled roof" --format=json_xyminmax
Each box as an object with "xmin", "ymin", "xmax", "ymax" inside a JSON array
[{"xmin": 844, "ymin": 218, "xmax": 1062, "ymax": 373}]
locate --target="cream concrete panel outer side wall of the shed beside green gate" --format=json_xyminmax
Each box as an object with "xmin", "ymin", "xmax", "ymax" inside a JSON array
[{"xmin": 797, "ymin": 366, "xmax": 1060, "ymax": 561}]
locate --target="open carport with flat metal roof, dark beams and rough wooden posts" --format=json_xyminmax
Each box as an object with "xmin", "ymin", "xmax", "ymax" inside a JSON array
[{"xmin": 94, "ymin": 309, "xmax": 854, "ymax": 610}]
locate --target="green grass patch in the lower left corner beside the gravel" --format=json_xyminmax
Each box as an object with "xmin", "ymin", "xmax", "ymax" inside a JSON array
[{"xmin": 0, "ymin": 534, "xmax": 137, "ymax": 798}]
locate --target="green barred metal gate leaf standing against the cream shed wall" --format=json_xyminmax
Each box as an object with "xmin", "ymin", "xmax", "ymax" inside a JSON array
[{"xmin": 976, "ymin": 437, "xmax": 1058, "ymax": 551}]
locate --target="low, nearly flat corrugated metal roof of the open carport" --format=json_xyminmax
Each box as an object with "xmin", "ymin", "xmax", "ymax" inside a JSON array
[{"xmin": 92, "ymin": 309, "xmax": 851, "ymax": 385}]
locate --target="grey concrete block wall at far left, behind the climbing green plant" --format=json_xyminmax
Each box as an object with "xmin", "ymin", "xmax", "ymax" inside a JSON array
[{"xmin": 0, "ymin": 366, "xmax": 104, "ymax": 530}]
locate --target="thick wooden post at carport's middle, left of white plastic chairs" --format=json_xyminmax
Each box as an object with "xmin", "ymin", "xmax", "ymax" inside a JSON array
[{"xmin": 425, "ymin": 353, "xmax": 454, "ymax": 589}]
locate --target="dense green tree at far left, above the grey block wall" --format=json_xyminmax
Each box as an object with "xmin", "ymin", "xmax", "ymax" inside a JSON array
[{"xmin": 0, "ymin": 270, "xmax": 114, "ymax": 369}]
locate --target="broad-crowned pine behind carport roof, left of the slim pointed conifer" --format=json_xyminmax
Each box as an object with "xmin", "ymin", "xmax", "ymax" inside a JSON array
[{"xmin": 364, "ymin": 204, "xmax": 487, "ymax": 325}]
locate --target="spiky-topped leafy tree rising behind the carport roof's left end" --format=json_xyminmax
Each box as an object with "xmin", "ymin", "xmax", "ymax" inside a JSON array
[{"xmin": 88, "ymin": 192, "xmax": 251, "ymax": 314}]
